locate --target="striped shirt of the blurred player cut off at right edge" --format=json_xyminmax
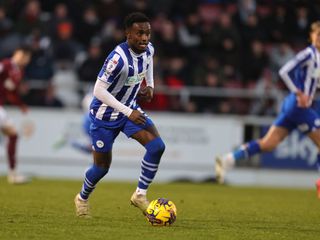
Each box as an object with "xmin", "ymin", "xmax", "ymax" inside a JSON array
[{"xmin": 279, "ymin": 45, "xmax": 320, "ymax": 99}]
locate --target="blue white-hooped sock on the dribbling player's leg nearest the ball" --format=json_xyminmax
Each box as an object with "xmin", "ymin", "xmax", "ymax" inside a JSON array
[{"xmin": 138, "ymin": 137, "xmax": 165, "ymax": 189}]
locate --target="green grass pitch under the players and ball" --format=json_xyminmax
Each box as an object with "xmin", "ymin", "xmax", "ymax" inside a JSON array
[{"xmin": 0, "ymin": 178, "xmax": 320, "ymax": 240}]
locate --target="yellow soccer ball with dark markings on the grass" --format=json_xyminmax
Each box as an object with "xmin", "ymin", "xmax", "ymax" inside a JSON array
[{"xmin": 146, "ymin": 198, "xmax": 177, "ymax": 226}]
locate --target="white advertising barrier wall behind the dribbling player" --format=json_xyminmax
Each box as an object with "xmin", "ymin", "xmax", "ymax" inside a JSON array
[{"xmin": 0, "ymin": 109, "xmax": 243, "ymax": 181}]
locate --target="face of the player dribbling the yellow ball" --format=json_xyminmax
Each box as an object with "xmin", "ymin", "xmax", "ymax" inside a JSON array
[{"xmin": 127, "ymin": 22, "xmax": 151, "ymax": 53}]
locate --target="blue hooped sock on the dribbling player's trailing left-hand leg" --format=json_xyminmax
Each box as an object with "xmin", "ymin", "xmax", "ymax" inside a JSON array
[{"xmin": 80, "ymin": 164, "xmax": 109, "ymax": 200}]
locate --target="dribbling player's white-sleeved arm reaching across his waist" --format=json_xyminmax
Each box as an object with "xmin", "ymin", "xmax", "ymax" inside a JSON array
[{"xmin": 93, "ymin": 54, "xmax": 146, "ymax": 124}]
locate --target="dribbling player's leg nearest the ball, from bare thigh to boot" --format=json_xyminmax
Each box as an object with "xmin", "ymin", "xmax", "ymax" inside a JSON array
[{"xmin": 125, "ymin": 122, "xmax": 165, "ymax": 213}]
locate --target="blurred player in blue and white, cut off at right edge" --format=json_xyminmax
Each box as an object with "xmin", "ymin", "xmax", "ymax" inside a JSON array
[{"xmin": 215, "ymin": 21, "xmax": 320, "ymax": 193}]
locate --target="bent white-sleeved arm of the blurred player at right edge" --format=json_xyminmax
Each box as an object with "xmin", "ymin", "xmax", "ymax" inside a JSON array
[{"xmin": 279, "ymin": 49, "xmax": 311, "ymax": 108}]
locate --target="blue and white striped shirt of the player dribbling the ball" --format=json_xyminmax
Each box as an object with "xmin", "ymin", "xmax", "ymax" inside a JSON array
[{"xmin": 90, "ymin": 42, "xmax": 154, "ymax": 122}]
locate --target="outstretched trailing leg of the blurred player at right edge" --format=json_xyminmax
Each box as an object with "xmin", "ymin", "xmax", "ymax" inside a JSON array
[{"xmin": 215, "ymin": 125, "xmax": 289, "ymax": 183}]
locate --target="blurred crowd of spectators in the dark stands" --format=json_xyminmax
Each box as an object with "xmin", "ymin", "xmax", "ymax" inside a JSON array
[{"xmin": 0, "ymin": 0, "xmax": 320, "ymax": 115}]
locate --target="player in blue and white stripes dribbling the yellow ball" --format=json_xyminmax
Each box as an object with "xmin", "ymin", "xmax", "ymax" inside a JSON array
[{"xmin": 74, "ymin": 12, "xmax": 165, "ymax": 216}]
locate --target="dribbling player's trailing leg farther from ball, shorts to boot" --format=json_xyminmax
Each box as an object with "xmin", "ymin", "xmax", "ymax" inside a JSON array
[{"xmin": 74, "ymin": 124, "xmax": 119, "ymax": 217}]
